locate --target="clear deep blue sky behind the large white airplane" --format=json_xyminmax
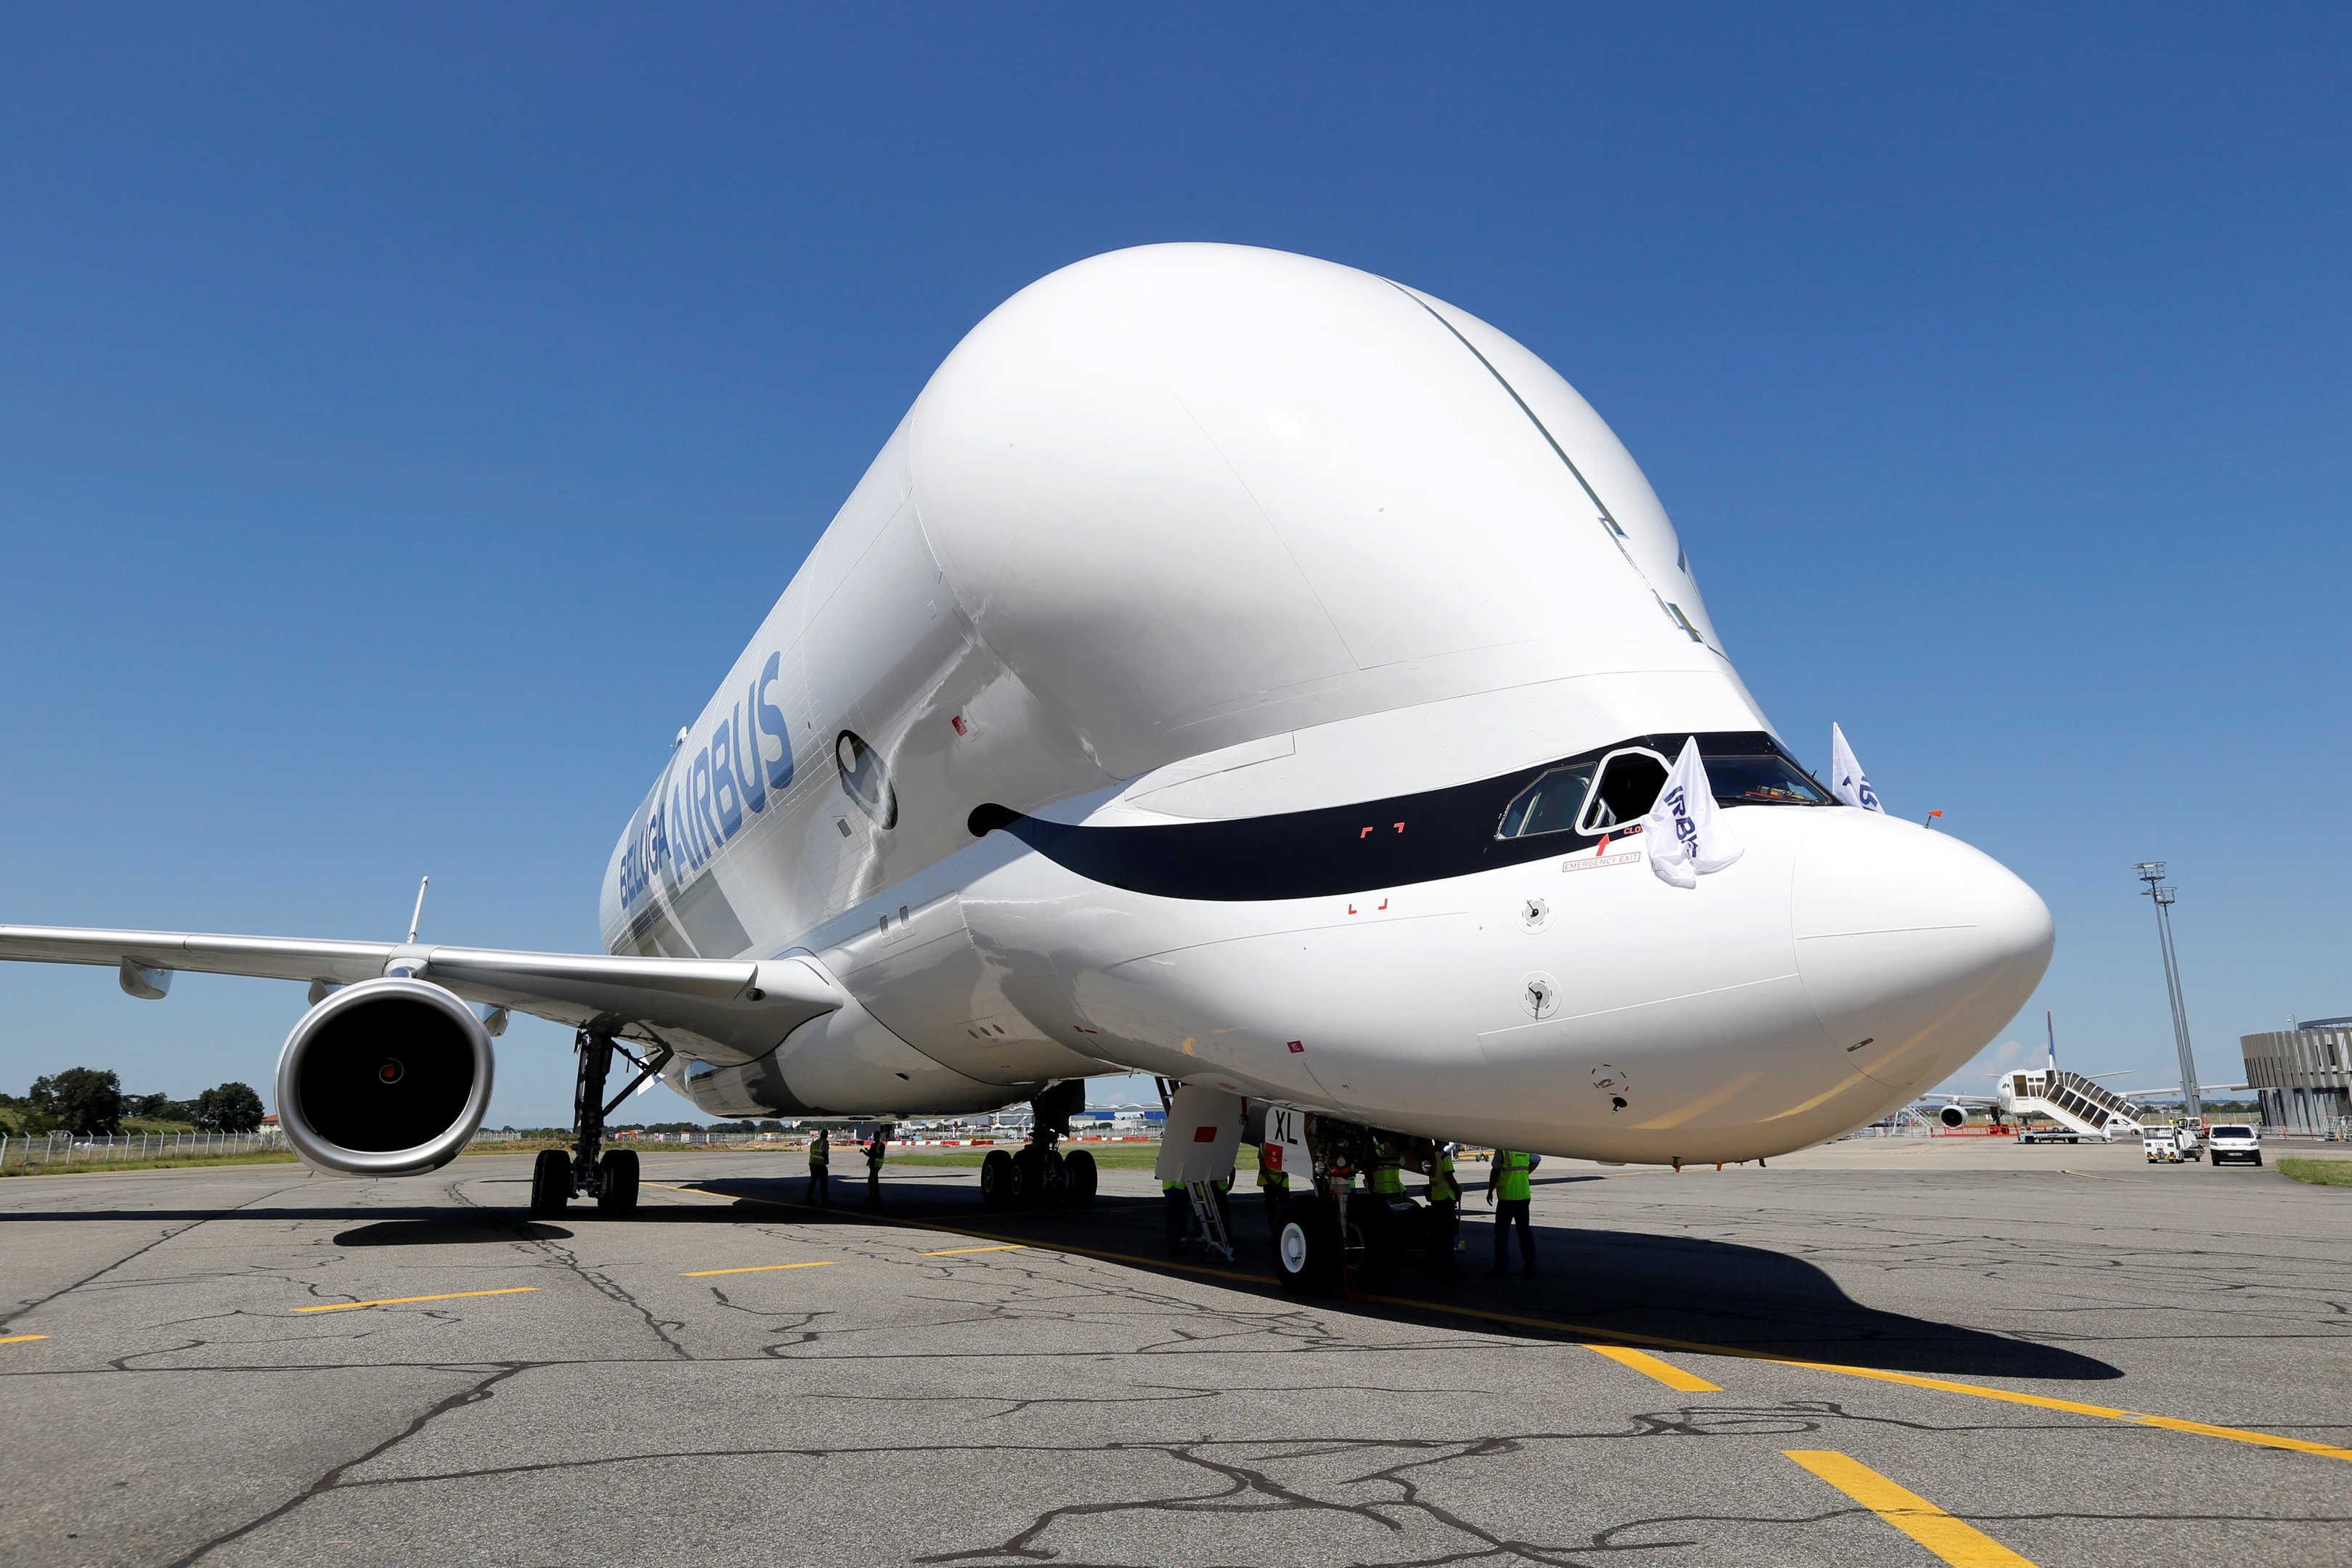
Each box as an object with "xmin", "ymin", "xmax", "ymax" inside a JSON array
[{"xmin": 0, "ymin": 4, "xmax": 2352, "ymax": 1122}]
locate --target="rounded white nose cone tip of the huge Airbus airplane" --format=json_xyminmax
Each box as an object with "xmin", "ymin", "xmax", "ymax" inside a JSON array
[{"xmin": 1790, "ymin": 811, "xmax": 2054, "ymax": 1091}]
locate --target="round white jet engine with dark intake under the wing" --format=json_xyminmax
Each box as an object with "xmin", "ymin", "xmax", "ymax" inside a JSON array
[{"xmin": 277, "ymin": 978, "xmax": 492, "ymax": 1175}]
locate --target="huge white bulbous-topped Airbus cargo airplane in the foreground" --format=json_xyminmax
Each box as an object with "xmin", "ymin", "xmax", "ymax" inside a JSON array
[{"xmin": 0, "ymin": 245, "xmax": 2054, "ymax": 1281}]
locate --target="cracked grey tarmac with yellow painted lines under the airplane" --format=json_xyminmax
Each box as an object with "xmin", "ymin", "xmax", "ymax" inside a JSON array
[{"xmin": 0, "ymin": 1138, "xmax": 2352, "ymax": 1568}]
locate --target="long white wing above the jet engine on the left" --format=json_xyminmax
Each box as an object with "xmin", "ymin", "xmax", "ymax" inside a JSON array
[{"xmin": 0, "ymin": 926, "xmax": 845, "ymax": 1061}]
